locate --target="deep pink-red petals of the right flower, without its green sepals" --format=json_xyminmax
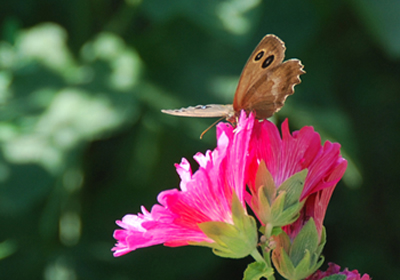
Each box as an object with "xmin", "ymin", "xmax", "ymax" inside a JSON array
[{"xmin": 246, "ymin": 116, "xmax": 347, "ymax": 237}]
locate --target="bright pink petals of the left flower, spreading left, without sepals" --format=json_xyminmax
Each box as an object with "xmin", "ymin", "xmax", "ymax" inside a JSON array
[{"xmin": 112, "ymin": 111, "xmax": 253, "ymax": 256}]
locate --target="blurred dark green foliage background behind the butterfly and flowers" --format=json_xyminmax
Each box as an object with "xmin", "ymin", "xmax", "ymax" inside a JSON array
[{"xmin": 0, "ymin": 0, "xmax": 400, "ymax": 280}]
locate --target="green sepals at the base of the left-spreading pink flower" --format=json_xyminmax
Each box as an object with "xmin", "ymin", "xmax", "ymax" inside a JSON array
[{"xmin": 190, "ymin": 193, "xmax": 258, "ymax": 259}]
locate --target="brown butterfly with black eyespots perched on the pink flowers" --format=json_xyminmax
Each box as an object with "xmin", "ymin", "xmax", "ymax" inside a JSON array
[{"xmin": 161, "ymin": 34, "xmax": 305, "ymax": 138}]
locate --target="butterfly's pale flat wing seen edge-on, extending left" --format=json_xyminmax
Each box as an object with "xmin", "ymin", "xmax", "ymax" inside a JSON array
[{"xmin": 161, "ymin": 104, "xmax": 234, "ymax": 119}]
